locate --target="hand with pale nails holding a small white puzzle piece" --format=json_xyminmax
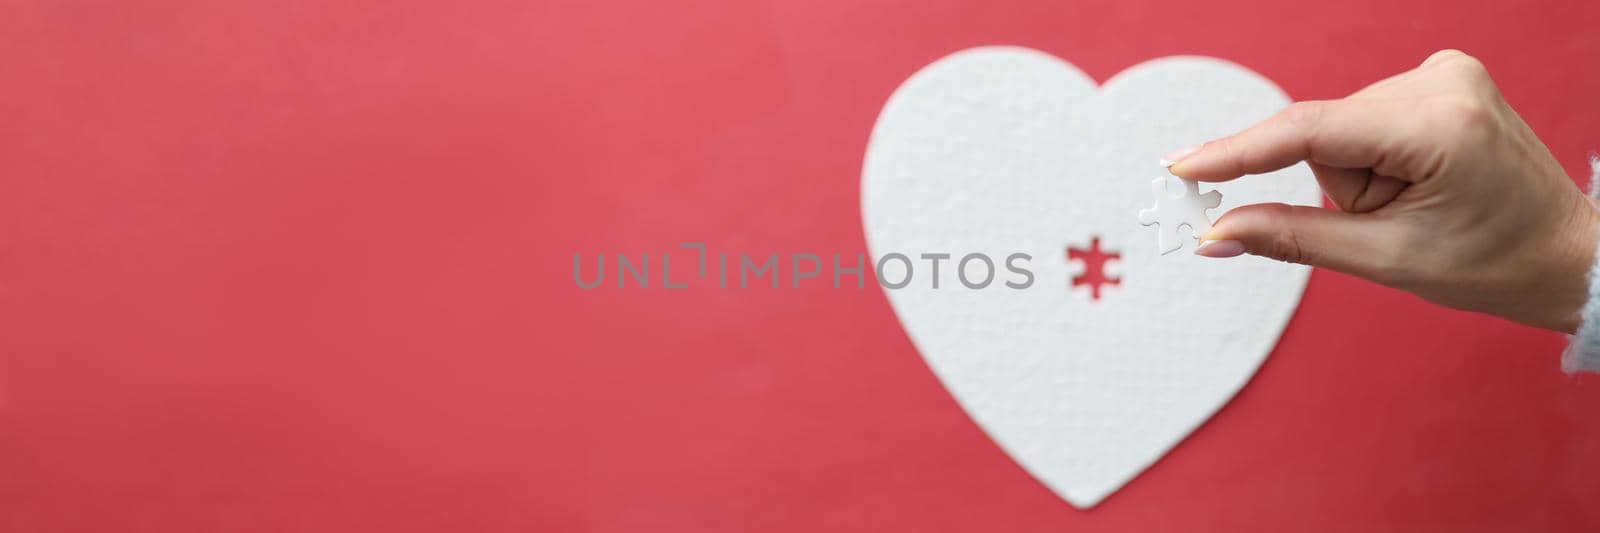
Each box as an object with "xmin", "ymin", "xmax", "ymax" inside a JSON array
[{"xmin": 1168, "ymin": 50, "xmax": 1600, "ymax": 333}]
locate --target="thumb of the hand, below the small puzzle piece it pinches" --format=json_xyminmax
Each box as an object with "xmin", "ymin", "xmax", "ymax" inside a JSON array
[{"xmin": 1195, "ymin": 203, "xmax": 1395, "ymax": 282}]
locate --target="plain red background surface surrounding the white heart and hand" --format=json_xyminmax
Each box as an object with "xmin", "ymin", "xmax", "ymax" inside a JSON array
[{"xmin": 0, "ymin": 0, "xmax": 1600, "ymax": 531}]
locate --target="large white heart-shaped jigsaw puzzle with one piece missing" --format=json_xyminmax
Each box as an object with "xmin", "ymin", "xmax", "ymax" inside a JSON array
[{"xmin": 862, "ymin": 46, "xmax": 1322, "ymax": 507}]
